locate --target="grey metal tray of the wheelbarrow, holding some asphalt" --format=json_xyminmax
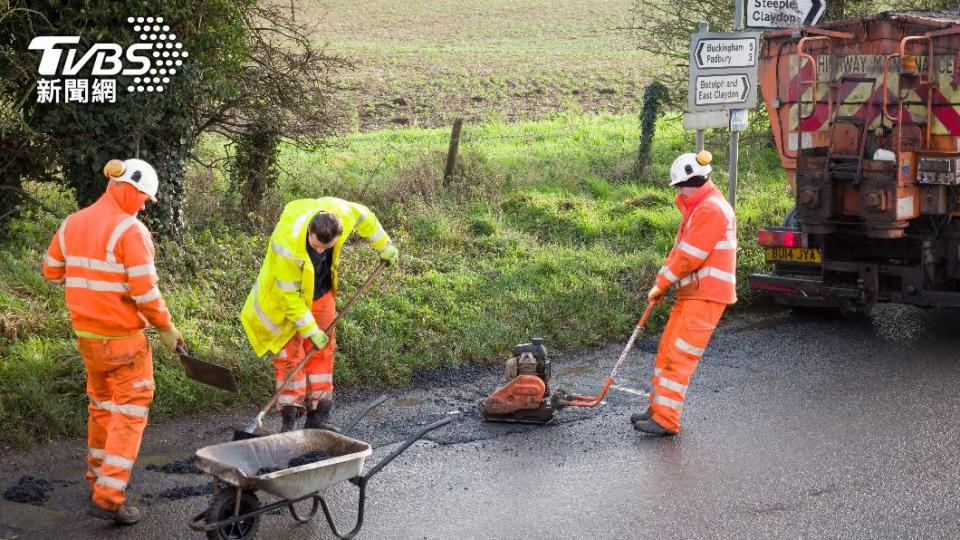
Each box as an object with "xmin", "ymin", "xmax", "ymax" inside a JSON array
[{"xmin": 196, "ymin": 429, "xmax": 373, "ymax": 499}]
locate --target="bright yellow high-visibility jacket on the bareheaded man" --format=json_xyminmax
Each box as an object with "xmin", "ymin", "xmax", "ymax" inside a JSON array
[{"xmin": 240, "ymin": 197, "xmax": 391, "ymax": 356}]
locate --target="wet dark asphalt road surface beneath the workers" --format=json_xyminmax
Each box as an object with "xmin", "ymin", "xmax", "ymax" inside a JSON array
[{"xmin": 0, "ymin": 307, "xmax": 960, "ymax": 539}]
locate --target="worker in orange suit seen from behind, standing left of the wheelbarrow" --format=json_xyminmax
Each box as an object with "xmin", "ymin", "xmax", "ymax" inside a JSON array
[{"xmin": 43, "ymin": 159, "xmax": 183, "ymax": 525}]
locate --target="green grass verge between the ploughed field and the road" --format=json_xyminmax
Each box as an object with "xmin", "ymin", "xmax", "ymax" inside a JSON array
[{"xmin": 0, "ymin": 115, "xmax": 788, "ymax": 444}]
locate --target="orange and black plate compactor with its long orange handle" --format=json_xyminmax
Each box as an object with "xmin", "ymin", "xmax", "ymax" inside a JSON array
[{"xmin": 480, "ymin": 301, "xmax": 659, "ymax": 424}]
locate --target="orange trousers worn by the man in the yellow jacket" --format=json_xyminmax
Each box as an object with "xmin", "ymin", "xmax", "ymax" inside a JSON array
[{"xmin": 273, "ymin": 291, "xmax": 337, "ymax": 411}]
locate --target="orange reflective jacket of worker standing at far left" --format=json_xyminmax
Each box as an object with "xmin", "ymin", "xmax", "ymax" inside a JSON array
[{"xmin": 43, "ymin": 191, "xmax": 171, "ymax": 336}]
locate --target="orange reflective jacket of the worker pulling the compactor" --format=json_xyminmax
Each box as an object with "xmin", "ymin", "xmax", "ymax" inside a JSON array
[{"xmin": 657, "ymin": 181, "xmax": 737, "ymax": 304}]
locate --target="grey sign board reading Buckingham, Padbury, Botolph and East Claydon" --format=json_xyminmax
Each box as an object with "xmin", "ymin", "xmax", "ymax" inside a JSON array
[{"xmin": 687, "ymin": 32, "xmax": 760, "ymax": 113}]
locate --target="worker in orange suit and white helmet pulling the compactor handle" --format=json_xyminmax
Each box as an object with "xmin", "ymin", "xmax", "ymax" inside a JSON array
[{"xmin": 630, "ymin": 151, "xmax": 737, "ymax": 435}]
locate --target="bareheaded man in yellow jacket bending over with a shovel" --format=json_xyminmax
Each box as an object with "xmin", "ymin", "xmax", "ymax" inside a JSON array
[{"xmin": 246, "ymin": 197, "xmax": 398, "ymax": 431}]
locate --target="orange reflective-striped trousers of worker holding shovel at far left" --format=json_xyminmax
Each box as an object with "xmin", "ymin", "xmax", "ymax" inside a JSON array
[{"xmin": 77, "ymin": 332, "xmax": 154, "ymax": 511}]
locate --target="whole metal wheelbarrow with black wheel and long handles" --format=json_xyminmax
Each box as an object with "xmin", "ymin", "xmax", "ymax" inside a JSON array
[{"xmin": 190, "ymin": 397, "xmax": 451, "ymax": 540}]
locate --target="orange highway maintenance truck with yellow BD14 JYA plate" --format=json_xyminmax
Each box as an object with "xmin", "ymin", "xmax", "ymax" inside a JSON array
[{"xmin": 750, "ymin": 11, "xmax": 960, "ymax": 313}]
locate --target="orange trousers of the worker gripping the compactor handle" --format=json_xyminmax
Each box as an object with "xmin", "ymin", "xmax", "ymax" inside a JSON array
[{"xmin": 650, "ymin": 299, "xmax": 727, "ymax": 431}]
